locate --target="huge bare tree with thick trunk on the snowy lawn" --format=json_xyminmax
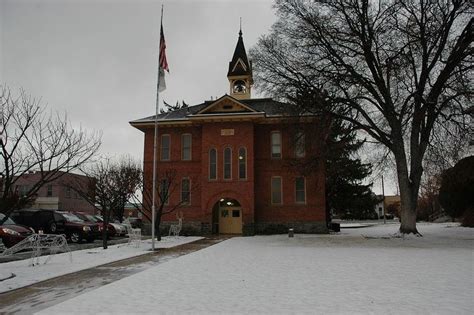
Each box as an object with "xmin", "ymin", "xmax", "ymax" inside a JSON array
[{"xmin": 251, "ymin": 0, "xmax": 474, "ymax": 234}]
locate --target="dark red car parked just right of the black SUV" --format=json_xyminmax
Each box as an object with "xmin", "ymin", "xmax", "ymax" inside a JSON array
[{"xmin": 57, "ymin": 211, "xmax": 100, "ymax": 243}]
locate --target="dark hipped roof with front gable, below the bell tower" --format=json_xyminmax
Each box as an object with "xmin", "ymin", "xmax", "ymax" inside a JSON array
[{"xmin": 130, "ymin": 94, "xmax": 296, "ymax": 125}]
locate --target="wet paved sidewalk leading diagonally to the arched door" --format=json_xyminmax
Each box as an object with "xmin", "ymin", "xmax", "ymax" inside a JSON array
[{"xmin": 0, "ymin": 237, "xmax": 230, "ymax": 314}]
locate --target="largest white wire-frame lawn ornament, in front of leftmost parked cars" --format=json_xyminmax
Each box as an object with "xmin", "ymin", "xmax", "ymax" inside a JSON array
[{"xmin": 2, "ymin": 234, "xmax": 72, "ymax": 266}]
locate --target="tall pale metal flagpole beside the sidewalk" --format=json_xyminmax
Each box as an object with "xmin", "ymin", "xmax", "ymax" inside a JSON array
[{"xmin": 151, "ymin": 4, "xmax": 167, "ymax": 251}]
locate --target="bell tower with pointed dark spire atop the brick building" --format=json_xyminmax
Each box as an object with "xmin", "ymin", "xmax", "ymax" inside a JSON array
[{"xmin": 227, "ymin": 26, "xmax": 253, "ymax": 100}]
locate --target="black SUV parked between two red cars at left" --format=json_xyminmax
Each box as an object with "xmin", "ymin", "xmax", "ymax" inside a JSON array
[{"xmin": 10, "ymin": 209, "xmax": 66, "ymax": 234}]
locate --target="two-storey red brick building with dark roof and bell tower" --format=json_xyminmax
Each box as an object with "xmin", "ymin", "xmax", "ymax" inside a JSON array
[{"xmin": 131, "ymin": 32, "xmax": 327, "ymax": 235}]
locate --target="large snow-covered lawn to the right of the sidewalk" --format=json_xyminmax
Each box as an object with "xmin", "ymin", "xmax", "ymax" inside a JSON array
[{"xmin": 36, "ymin": 224, "xmax": 474, "ymax": 314}]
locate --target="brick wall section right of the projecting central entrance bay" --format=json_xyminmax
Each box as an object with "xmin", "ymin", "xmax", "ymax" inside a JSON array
[{"xmin": 255, "ymin": 124, "xmax": 326, "ymax": 222}]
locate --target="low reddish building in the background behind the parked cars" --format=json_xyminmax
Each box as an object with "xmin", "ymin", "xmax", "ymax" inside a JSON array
[{"xmin": 16, "ymin": 172, "xmax": 95, "ymax": 214}]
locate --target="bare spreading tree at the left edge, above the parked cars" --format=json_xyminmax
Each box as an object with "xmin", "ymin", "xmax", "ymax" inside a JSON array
[{"xmin": 0, "ymin": 86, "xmax": 101, "ymax": 220}]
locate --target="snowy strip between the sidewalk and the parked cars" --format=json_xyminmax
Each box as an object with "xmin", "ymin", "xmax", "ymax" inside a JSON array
[{"xmin": 0, "ymin": 237, "xmax": 202, "ymax": 293}]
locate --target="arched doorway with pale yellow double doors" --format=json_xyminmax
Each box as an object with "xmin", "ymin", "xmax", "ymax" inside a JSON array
[{"xmin": 212, "ymin": 198, "xmax": 242, "ymax": 234}]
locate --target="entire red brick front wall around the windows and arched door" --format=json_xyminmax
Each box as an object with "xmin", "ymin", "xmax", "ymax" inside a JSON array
[{"xmin": 144, "ymin": 122, "xmax": 325, "ymax": 233}]
